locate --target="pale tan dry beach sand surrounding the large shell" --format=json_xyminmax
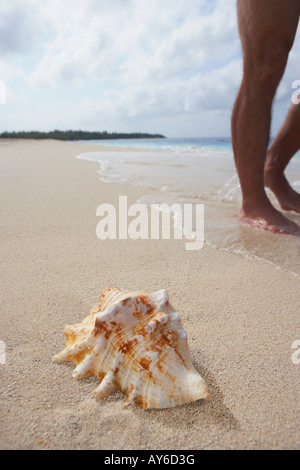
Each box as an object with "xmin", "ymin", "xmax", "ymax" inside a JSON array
[{"xmin": 0, "ymin": 141, "xmax": 300, "ymax": 450}]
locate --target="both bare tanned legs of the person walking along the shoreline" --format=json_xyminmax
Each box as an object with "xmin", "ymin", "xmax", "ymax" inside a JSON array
[{"xmin": 232, "ymin": 0, "xmax": 300, "ymax": 235}]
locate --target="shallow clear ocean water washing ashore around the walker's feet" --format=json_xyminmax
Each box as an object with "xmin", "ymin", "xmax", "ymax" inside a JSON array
[{"xmin": 78, "ymin": 138, "xmax": 300, "ymax": 276}]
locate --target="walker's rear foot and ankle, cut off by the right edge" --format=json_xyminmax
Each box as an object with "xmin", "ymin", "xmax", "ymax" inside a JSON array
[{"xmin": 265, "ymin": 167, "xmax": 300, "ymax": 214}]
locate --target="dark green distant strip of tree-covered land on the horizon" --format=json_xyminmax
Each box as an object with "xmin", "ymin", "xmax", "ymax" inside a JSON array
[{"xmin": 0, "ymin": 130, "xmax": 165, "ymax": 140}]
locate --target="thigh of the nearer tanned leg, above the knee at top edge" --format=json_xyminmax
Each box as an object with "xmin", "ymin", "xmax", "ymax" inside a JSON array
[{"xmin": 237, "ymin": 0, "xmax": 300, "ymax": 62}]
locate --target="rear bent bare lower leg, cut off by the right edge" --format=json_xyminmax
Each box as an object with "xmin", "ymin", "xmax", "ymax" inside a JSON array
[{"xmin": 265, "ymin": 104, "xmax": 300, "ymax": 213}]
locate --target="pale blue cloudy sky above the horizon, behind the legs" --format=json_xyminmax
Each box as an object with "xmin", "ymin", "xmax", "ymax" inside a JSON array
[{"xmin": 0, "ymin": 0, "xmax": 300, "ymax": 137}]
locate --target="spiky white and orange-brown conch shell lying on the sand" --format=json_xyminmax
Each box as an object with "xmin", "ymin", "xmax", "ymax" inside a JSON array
[{"xmin": 53, "ymin": 288, "xmax": 209, "ymax": 409}]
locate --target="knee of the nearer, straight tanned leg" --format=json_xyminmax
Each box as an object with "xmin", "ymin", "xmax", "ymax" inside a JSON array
[{"xmin": 244, "ymin": 43, "xmax": 290, "ymax": 101}]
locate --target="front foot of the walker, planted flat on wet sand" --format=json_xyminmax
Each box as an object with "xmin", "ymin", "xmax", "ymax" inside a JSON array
[{"xmin": 239, "ymin": 199, "xmax": 300, "ymax": 236}]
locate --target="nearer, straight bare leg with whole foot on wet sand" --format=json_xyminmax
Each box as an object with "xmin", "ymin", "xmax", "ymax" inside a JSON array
[{"xmin": 232, "ymin": 0, "xmax": 300, "ymax": 233}]
